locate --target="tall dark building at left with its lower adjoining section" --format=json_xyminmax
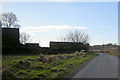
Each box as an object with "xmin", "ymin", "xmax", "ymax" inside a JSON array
[{"xmin": 2, "ymin": 28, "xmax": 40, "ymax": 54}]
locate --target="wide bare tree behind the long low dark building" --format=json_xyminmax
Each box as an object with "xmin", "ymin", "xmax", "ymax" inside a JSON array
[{"xmin": 62, "ymin": 30, "xmax": 88, "ymax": 44}]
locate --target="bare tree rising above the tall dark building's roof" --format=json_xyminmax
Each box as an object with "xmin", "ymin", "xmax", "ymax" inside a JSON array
[{"xmin": 0, "ymin": 13, "xmax": 20, "ymax": 28}]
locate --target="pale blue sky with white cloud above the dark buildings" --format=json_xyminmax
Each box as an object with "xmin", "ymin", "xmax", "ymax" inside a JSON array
[{"xmin": 1, "ymin": 2, "xmax": 118, "ymax": 47}]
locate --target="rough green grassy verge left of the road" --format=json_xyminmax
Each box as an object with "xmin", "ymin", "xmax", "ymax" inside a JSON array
[{"xmin": 2, "ymin": 52, "xmax": 97, "ymax": 80}]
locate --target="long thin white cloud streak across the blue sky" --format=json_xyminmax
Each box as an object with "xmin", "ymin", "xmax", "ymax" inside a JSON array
[{"xmin": 20, "ymin": 25, "xmax": 88, "ymax": 32}]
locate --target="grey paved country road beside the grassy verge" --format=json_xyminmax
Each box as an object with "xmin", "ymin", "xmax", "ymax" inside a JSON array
[{"xmin": 72, "ymin": 53, "xmax": 118, "ymax": 78}]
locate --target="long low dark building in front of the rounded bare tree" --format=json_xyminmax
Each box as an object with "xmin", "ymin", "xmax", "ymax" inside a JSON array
[{"xmin": 50, "ymin": 42, "xmax": 89, "ymax": 52}]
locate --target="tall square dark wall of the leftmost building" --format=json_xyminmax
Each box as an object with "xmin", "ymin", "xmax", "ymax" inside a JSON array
[{"xmin": 2, "ymin": 28, "xmax": 20, "ymax": 47}]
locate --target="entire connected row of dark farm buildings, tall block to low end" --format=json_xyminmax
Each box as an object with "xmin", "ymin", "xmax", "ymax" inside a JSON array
[{"xmin": 2, "ymin": 28, "xmax": 89, "ymax": 54}]
